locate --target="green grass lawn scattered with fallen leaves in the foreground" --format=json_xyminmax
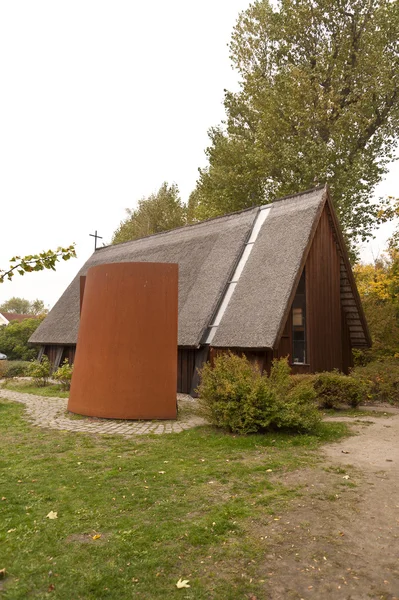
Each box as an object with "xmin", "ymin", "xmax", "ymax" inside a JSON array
[{"xmin": 0, "ymin": 390, "xmax": 347, "ymax": 600}]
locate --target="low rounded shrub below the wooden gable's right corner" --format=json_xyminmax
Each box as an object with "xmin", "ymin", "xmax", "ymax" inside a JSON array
[{"xmin": 313, "ymin": 371, "xmax": 367, "ymax": 408}]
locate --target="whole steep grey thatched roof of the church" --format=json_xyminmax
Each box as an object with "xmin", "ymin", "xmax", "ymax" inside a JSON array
[{"xmin": 30, "ymin": 188, "xmax": 370, "ymax": 348}]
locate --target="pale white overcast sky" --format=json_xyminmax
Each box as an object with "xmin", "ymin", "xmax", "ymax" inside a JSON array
[{"xmin": 0, "ymin": 0, "xmax": 399, "ymax": 305}]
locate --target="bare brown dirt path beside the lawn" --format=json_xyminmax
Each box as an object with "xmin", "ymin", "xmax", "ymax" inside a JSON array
[{"xmin": 258, "ymin": 409, "xmax": 399, "ymax": 600}]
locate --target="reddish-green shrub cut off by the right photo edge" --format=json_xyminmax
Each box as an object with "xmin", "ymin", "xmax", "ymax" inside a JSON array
[{"xmin": 351, "ymin": 358, "xmax": 399, "ymax": 404}]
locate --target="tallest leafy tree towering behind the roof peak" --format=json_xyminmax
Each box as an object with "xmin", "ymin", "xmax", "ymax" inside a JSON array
[{"xmin": 195, "ymin": 0, "xmax": 399, "ymax": 247}]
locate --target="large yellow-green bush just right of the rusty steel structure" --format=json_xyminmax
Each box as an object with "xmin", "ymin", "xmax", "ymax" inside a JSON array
[{"xmin": 198, "ymin": 352, "xmax": 320, "ymax": 433}]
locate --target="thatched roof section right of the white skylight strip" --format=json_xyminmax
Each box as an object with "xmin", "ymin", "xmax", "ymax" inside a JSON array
[{"xmin": 212, "ymin": 189, "xmax": 325, "ymax": 348}]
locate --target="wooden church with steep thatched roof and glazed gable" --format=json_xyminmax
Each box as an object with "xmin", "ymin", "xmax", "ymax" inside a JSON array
[{"xmin": 30, "ymin": 187, "xmax": 371, "ymax": 393}]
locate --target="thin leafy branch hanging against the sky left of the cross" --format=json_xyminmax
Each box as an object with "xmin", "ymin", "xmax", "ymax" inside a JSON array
[{"xmin": 0, "ymin": 244, "xmax": 76, "ymax": 283}]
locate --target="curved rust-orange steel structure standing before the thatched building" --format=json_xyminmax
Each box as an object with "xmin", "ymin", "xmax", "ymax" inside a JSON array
[{"xmin": 68, "ymin": 263, "xmax": 178, "ymax": 419}]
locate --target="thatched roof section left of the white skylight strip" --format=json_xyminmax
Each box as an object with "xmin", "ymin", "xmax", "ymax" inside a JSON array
[{"xmin": 29, "ymin": 208, "xmax": 259, "ymax": 347}]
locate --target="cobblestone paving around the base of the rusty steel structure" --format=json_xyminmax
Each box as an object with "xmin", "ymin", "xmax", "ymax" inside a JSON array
[{"xmin": 0, "ymin": 389, "xmax": 205, "ymax": 437}]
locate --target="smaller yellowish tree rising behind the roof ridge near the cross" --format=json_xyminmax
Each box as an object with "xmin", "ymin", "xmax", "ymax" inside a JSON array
[{"xmin": 112, "ymin": 182, "xmax": 187, "ymax": 244}]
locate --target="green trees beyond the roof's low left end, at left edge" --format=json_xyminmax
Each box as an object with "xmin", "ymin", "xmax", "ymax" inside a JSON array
[{"xmin": 0, "ymin": 317, "xmax": 44, "ymax": 361}]
